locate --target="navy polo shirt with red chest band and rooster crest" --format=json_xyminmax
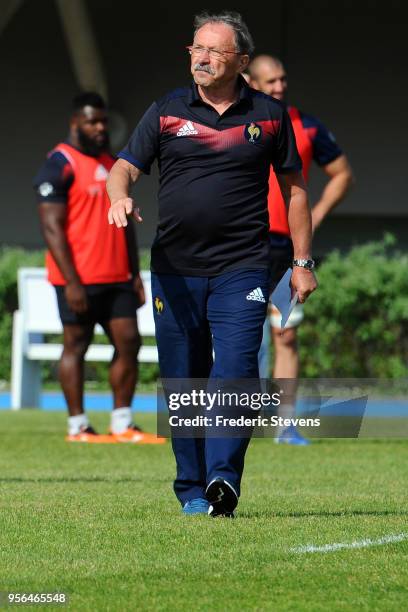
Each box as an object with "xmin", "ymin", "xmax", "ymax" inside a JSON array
[{"xmin": 119, "ymin": 77, "xmax": 302, "ymax": 276}]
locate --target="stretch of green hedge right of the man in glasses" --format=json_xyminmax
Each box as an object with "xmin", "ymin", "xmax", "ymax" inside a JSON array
[{"xmin": 299, "ymin": 234, "xmax": 408, "ymax": 378}]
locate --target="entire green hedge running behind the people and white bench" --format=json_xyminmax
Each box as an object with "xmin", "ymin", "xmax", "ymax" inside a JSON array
[{"xmin": 0, "ymin": 235, "xmax": 408, "ymax": 386}]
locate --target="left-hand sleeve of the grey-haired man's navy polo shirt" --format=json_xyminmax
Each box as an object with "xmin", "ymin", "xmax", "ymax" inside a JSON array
[{"xmin": 118, "ymin": 102, "xmax": 160, "ymax": 174}]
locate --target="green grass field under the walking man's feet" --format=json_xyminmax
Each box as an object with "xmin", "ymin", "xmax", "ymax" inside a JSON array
[{"xmin": 0, "ymin": 410, "xmax": 408, "ymax": 612}]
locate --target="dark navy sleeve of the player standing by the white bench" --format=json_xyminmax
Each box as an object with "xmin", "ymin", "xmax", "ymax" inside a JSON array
[{"xmin": 34, "ymin": 151, "xmax": 74, "ymax": 204}]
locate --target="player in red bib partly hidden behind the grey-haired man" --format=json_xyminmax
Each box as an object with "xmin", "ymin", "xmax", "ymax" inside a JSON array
[{"xmin": 248, "ymin": 55, "xmax": 353, "ymax": 445}]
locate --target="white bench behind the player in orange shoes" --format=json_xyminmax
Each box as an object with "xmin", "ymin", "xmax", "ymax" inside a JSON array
[{"xmin": 11, "ymin": 268, "xmax": 158, "ymax": 410}]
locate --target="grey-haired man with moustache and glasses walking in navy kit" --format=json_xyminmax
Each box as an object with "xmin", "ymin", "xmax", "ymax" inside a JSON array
[{"xmin": 107, "ymin": 12, "xmax": 316, "ymax": 516}]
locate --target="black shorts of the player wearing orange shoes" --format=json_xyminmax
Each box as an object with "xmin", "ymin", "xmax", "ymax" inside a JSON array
[{"xmin": 55, "ymin": 282, "xmax": 140, "ymax": 325}]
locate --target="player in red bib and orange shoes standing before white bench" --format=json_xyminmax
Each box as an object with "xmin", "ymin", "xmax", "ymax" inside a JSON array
[{"xmin": 34, "ymin": 92, "xmax": 164, "ymax": 443}]
